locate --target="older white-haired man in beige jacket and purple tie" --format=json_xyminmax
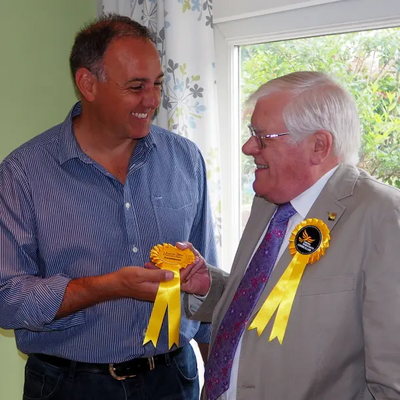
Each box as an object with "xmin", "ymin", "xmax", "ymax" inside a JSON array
[{"xmin": 183, "ymin": 72, "xmax": 400, "ymax": 400}]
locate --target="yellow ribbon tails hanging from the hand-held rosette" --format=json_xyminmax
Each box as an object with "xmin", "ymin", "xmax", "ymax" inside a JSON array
[{"xmin": 143, "ymin": 265, "xmax": 181, "ymax": 349}]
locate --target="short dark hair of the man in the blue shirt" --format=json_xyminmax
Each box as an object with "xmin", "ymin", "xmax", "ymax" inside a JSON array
[{"xmin": 69, "ymin": 14, "xmax": 152, "ymax": 82}]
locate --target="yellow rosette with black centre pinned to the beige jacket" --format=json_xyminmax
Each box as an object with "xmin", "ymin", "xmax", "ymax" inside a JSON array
[{"xmin": 248, "ymin": 218, "xmax": 330, "ymax": 344}]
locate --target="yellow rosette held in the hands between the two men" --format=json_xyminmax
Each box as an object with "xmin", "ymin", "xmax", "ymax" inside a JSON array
[{"xmin": 143, "ymin": 243, "xmax": 194, "ymax": 349}]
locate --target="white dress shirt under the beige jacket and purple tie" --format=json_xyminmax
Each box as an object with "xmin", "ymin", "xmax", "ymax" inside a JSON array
[{"xmin": 225, "ymin": 166, "xmax": 338, "ymax": 400}]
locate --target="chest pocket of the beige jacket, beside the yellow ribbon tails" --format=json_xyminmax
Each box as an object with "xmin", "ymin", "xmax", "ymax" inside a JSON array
[{"xmin": 300, "ymin": 274, "xmax": 356, "ymax": 296}]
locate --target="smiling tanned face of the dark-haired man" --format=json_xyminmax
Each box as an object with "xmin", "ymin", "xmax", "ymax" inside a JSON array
[{"xmin": 91, "ymin": 38, "xmax": 163, "ymax": 140}]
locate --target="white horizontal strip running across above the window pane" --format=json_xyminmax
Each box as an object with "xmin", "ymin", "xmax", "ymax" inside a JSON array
[{"xmin": 216, "ymin": 0, "xmax": 400, "ymax": 42}]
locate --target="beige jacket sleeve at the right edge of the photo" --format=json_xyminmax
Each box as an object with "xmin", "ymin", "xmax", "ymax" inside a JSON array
[{"xmin": 363, "ymin": 205, "xmax": 400, "ymax": 400}]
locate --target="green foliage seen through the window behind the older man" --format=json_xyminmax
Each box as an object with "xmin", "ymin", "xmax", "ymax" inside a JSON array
[{"xmin": 240, "ymin": 28, "xmax": 400, "ymax": 205}]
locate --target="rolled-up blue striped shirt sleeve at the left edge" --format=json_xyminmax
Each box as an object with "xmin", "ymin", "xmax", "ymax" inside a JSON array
[{"xmin": 0, "ymin": 159, "xmax": 79, "ymax": 331}]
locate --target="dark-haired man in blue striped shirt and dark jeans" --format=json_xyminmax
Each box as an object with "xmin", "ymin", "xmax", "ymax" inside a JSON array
[{"xmin": 0, "ymin": 15, "xmax": 216, "ymax": 400}]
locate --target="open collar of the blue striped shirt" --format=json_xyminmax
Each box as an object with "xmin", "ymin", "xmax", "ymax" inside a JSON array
[{"xmin": 58, "ymin": 101, "xmax": 157, "ymax": 164}]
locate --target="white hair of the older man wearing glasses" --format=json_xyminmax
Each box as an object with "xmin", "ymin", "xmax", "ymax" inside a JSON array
[{"xmin": 247, "ymin": 71, "xmax": 361, "ymax": 164}]
